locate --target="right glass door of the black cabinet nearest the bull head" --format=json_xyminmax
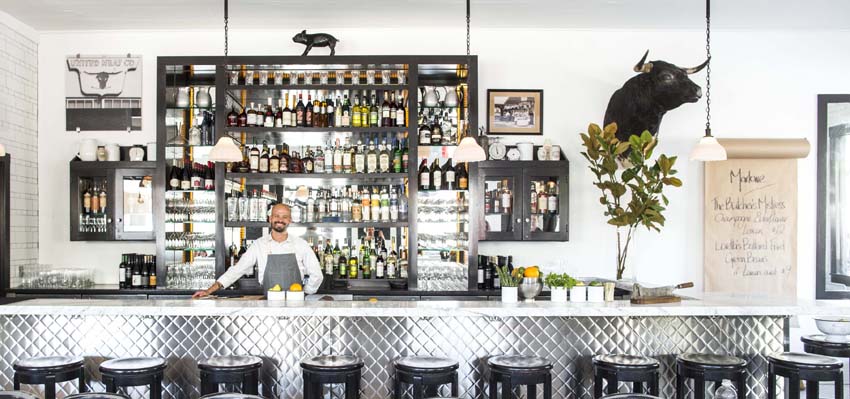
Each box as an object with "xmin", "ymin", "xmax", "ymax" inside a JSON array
[{"xmin": 523, "ymin": 168, "xmax": 567, "ymax": 241}]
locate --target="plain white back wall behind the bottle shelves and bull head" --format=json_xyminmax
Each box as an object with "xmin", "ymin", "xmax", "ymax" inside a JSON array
[{"xmin": 39, "ymin": 29, "xmax": 850, "ymax": 298}]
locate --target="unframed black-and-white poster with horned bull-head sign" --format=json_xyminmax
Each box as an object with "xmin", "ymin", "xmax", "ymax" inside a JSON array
[{"xmin": 65, "ymin": 54, "xmax": 142, "ymax": 131}]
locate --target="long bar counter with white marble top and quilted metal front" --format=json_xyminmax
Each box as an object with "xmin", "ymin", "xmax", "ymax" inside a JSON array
[{"xmin": 0, "ymin": 295, "xmax": 850, "ymax": 398}]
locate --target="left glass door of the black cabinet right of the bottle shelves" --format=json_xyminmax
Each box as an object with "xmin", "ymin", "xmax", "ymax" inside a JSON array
[{"xmin": 479, "ymin": 168, "xmax": 522, "ymax": 240}]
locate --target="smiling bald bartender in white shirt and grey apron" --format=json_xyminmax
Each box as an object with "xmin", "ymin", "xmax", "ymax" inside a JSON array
[{"xmin": 192, "ymin": 204, "xmax": 322, "ymax": 298}]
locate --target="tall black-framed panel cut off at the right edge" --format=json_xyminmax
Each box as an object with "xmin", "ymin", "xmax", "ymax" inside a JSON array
[{"xmin": 815, "ymin": 94, "xmax": 850, "ymax": 299}]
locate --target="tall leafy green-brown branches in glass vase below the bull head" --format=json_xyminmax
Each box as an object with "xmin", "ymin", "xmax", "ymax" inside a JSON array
[{"xmin": 581, "ymin": 123, "xmax": 682, "ymax": 280}]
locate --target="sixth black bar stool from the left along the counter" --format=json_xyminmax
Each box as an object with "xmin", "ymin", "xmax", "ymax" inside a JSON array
[{"xmin": 487, "ymin": 355, "xmax": 552, "ymax": 399}]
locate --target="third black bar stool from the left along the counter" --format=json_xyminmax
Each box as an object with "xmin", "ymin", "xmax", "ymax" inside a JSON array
[{"xmin": 198, "ymin": 356, "xmax": 263, "ymax": 395}]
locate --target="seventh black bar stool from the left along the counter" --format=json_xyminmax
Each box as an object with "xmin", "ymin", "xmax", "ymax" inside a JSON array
[{"xmin": 593, "ymin": 355, "xmax": 660, "ymax": 398}]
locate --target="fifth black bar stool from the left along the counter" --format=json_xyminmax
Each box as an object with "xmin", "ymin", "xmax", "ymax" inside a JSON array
[{"xmin": 393, "ymin": 356, "xmax": 459, "ymax": 399}]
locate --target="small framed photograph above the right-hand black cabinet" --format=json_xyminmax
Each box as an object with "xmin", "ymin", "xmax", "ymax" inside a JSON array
[{"xmin": 487, "ymin": 89, "xmax": 543, "ymax": 135}]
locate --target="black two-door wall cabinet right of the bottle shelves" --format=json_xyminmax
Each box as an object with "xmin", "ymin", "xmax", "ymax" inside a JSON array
[{"xmin": 478, "ymin": 161, "xmax": 569, "ymax": 241}]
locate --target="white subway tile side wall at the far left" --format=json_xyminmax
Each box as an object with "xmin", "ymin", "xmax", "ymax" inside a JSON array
[{"xmin": 0, "ymin": 22, "xmax": 38, "ymax": 285}]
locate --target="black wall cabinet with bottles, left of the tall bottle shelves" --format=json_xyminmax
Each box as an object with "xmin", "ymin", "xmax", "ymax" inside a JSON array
[{"xmin": 69, "ymin": 161, "xmax": 156, "ymax": 241}]
